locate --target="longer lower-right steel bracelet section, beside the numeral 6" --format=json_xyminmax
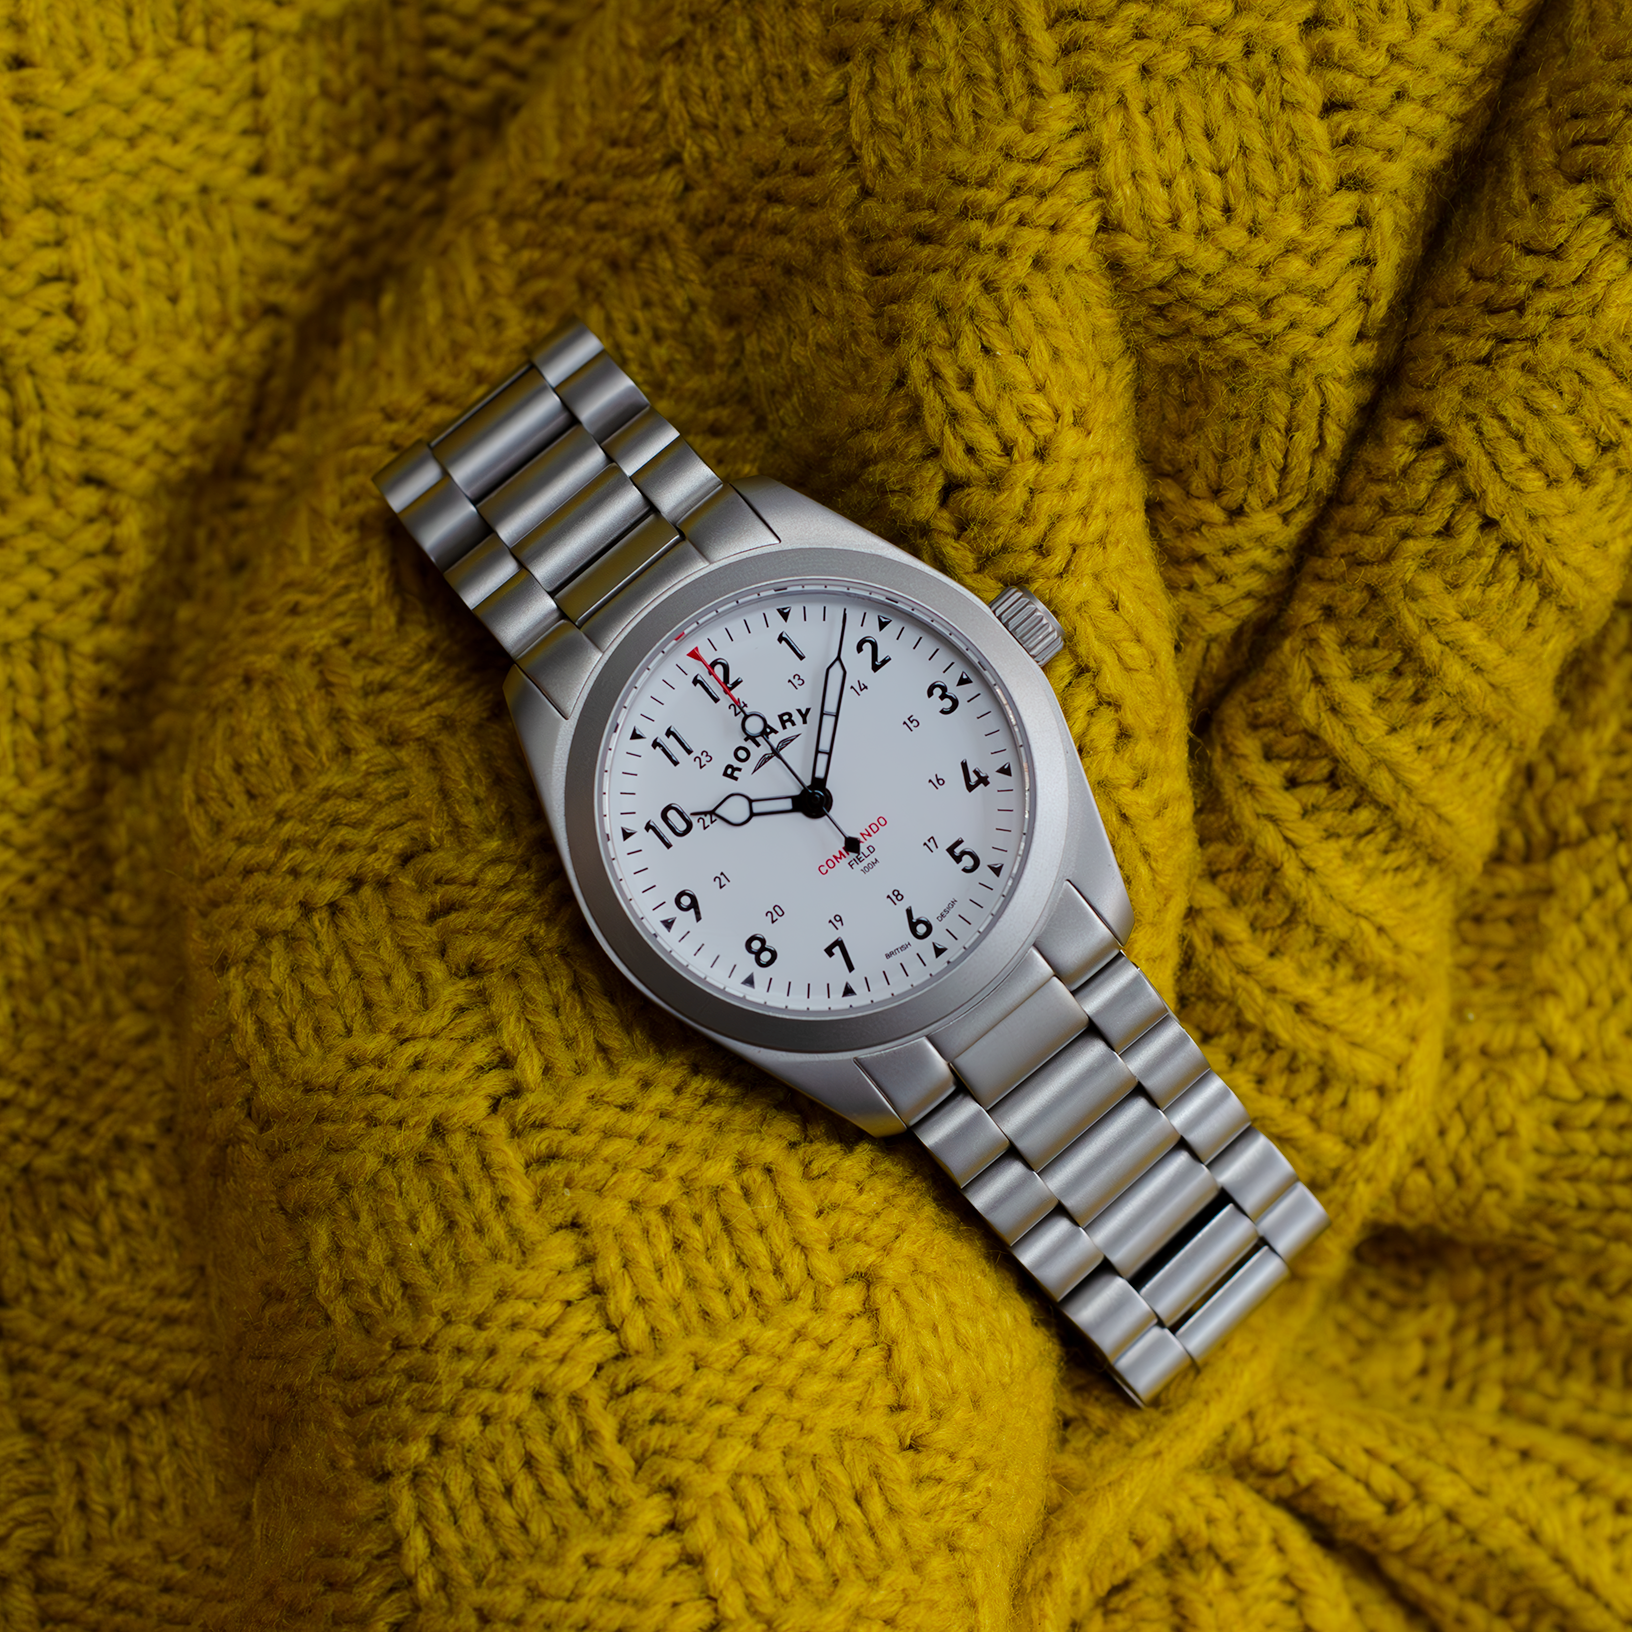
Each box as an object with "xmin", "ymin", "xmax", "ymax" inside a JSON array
[{"xmin": 858, "ymin": 883, "xmax": 1328, "ymax": 1405}]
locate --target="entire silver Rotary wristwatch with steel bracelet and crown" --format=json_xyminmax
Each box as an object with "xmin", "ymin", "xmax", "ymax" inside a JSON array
[{"xmin": 375, "ymin": 323, "xmax": 1327, "ymax": 1404}]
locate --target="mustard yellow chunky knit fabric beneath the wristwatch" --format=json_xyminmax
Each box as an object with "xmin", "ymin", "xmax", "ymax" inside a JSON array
[{"xmin": 0, "ymin": 0, "xmax": 1632, "ymax": 1632}]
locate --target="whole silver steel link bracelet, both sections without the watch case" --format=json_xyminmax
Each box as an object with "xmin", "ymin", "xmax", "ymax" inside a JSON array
[{"xmin": 375, "ymin": 323, "xmax": 1328, "ymax": 1404}]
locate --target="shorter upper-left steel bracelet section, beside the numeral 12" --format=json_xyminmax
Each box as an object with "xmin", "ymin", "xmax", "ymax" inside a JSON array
[{"xmin": 374, "ymin": 323, "xmax": 775, "ymax": 715}]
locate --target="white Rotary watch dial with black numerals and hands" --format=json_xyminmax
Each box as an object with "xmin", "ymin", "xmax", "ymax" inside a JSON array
[{"xmin": 597, "ymin": 583, "xmax": 1031, "ymax": 1012}]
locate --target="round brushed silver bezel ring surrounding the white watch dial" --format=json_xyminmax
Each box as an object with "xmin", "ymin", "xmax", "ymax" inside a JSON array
[{"xmin": 563, "ymin": 529, "xmax": 1082, "ymax": 1054}]
